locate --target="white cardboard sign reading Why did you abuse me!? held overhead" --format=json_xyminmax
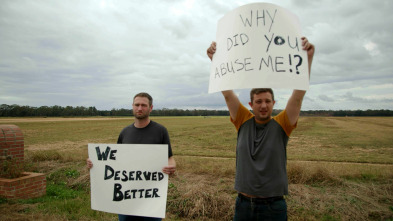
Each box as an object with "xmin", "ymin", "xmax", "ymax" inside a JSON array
[{"xmin": 209, "ymin": 3, "xmax": 309, "ymax": 93}]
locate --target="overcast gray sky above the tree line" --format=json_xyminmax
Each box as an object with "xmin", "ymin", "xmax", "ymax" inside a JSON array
[{"xmin": 0, "ymin": 0, "xmax": 393, "ymax": 110}]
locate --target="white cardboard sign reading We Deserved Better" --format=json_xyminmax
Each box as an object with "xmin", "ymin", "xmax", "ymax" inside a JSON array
[{"xmin": 88, "ymin": 144, "xmax": 168, "ymax": 218}]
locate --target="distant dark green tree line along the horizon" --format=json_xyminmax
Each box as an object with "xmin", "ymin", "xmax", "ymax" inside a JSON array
[{"xmin": 0, "ymin": 104, "xmax": 393, "ymax": 117}]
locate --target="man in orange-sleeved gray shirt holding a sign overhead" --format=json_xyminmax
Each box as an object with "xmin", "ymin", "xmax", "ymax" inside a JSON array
[{"xmin": 207, "ymin": 37, "xmax": 315, "ymax": 221}]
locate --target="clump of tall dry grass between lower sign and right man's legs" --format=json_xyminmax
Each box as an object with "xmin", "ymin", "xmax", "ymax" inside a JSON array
[{"xmin": 167, "ymin": 174, "xmax": 234, "ymax": 220}]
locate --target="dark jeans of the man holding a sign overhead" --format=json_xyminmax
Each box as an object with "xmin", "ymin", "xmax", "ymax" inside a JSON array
[{"xmin": 233, "ymin": 196, "xmax": 287, "ymax": 221}]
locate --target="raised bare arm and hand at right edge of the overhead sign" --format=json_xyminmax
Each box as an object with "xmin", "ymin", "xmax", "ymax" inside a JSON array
[{"xmin": 285, "ymin": 37, "xmax": 315, "ymax": 125}]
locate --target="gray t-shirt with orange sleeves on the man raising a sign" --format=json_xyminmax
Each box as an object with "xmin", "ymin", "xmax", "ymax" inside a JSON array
[{"xmin": 233, "ymin": 103, "xmax": 296, "ymax": 197}]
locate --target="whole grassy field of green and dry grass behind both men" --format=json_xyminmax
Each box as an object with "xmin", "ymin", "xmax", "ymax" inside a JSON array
[{"xmin": 0, "ymin": 117, "xmax": 393, "ymax": 220}]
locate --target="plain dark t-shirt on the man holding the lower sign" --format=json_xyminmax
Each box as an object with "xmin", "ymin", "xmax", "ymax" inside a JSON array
[{"xmin": 117, "ymin": 121, "xmax": 173, "ymax": 158}]
